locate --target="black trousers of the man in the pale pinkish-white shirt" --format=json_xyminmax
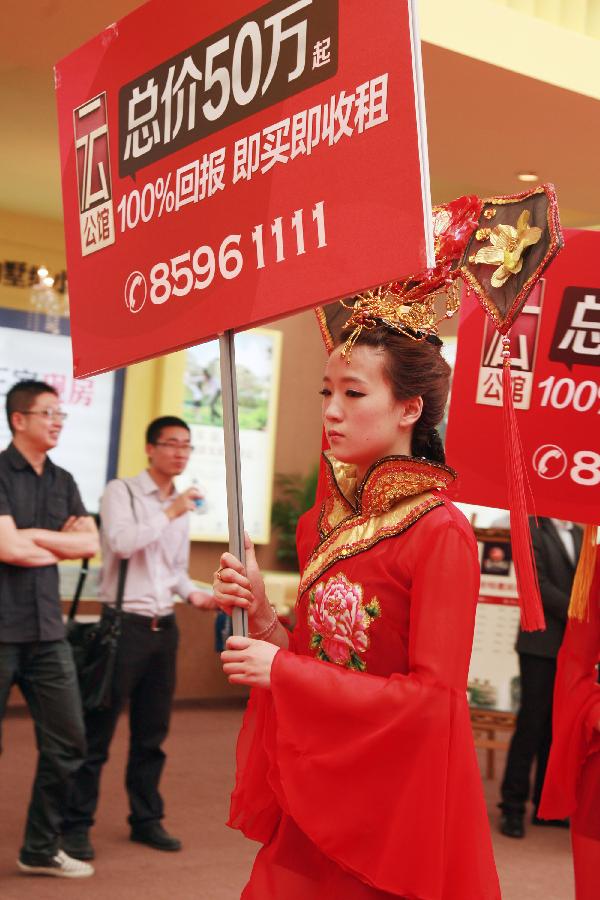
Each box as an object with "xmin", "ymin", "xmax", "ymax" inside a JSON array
[{"xmin": 63, "ymin": 615, "xmax": 179, "ymax": 832}]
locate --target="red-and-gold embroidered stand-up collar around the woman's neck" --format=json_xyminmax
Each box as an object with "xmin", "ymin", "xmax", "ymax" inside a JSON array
[{"xmin": 319, "ymin": 451, "xmax": 456, "ymax": 536}]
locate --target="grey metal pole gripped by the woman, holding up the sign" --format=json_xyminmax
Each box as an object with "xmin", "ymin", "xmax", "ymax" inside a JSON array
[{"xmin": 219, "ymin": 330, "xmax": 248, "ymax": 637}]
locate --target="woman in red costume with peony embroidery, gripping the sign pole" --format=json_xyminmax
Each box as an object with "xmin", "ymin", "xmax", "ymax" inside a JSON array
[{"xmin": 214, "ymin": 323, "xmax": 500, "ymax": 900}]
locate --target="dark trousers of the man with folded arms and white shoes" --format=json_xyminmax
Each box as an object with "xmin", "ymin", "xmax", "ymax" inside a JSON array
[{"xmin": 0, "ymin": 641, "xmax": 85, "ymax": 862}]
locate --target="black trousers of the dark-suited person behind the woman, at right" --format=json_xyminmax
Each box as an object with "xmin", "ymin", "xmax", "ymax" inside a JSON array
[{"xmin": 500, "ymin": 653, "xmax": 556, "ymax": 814}]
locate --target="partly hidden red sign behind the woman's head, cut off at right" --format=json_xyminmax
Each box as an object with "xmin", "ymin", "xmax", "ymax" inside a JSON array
[{"xmin": 446, "ymin": 230, "xmax": 600, "ymax": 523}]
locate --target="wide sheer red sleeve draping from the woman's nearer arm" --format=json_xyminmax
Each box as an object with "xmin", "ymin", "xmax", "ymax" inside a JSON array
[{"xmin": 230, "ymin": 521, "xmax": 500, "ymax": 900}]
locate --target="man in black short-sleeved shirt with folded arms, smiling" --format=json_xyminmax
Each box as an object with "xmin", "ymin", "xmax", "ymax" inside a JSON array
[{"xmin": 0, "ymin": 381, "xmax": 98, "ymax": 878}]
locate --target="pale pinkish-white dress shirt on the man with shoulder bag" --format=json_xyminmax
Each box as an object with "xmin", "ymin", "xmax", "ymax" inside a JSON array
[{"xmin": 100, "ymin": 471, "xmax": 197, "ymax": 616}]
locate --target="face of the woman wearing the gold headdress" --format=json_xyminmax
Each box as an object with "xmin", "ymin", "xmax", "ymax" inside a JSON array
[{"xmin": 322, "ymin": 344, "xmax": 422, "ymax": 478}]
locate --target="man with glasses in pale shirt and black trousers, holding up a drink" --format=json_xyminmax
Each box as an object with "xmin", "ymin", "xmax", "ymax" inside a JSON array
[{"xmin": 63, "ymin": 416, "xmax": 216, "ymax": 860}]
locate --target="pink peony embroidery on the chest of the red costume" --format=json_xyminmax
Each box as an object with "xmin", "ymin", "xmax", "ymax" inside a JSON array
[{"xmin": 308, "ymin": 573, "xmax": 381, "ymax": 672}]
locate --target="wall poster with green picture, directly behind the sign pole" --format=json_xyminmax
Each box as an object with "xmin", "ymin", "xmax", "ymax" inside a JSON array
[{"xmin": 178, "ymin": 328, "xmax": 282, "ymax": 544}]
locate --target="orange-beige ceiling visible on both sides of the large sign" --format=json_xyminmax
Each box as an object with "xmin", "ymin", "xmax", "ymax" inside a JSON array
[{"xmin": 0, "ymin": 0, "xmax": 600, "ymax": 226}]
